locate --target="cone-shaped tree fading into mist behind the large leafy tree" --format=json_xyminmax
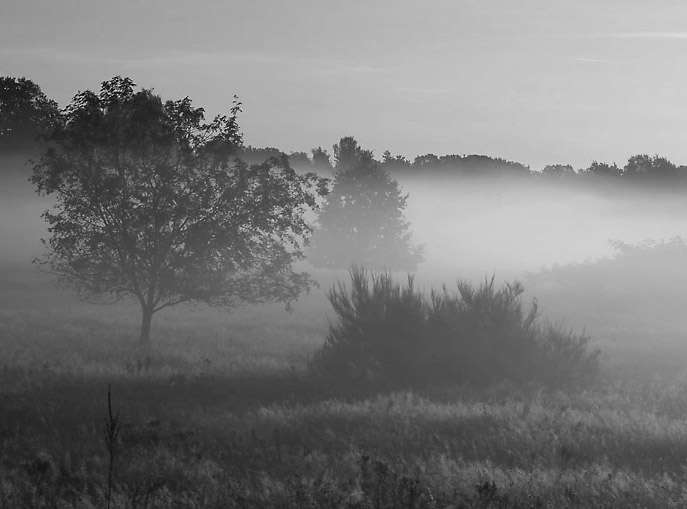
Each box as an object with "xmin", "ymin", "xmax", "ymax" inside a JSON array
[{"xmin": 308, "ymin": 137, "xmax": 422, "ymax": 270}]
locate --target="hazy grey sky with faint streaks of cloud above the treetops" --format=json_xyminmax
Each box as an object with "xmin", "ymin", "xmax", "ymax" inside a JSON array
[{"xmin": 0, "ymin": 0, "xmax": 687, "ymax": 169}]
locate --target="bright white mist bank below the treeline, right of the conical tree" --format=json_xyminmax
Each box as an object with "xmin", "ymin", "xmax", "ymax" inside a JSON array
[{"xmin": 404, "ymin": 178, "xmax": 687, "ymax": 277}]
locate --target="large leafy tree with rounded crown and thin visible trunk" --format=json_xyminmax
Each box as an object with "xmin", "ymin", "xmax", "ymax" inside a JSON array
[{"xmin": 32, "ymin": 77, "xmax": 325, "ymax": 343}]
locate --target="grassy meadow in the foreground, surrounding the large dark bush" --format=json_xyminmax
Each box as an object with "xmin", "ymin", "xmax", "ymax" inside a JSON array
[{"xmin": 0, "ymin": 271, "xmax": 687, "ymax": 508}]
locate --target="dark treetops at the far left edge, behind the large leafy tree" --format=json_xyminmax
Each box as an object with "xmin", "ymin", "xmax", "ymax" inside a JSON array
[{"xmin": 0, "ymin": 77, "xmax": 60, "ymax": 153}]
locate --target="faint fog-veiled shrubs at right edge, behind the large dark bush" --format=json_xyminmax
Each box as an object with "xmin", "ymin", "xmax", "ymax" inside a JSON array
[{"xmin": 525, "ymin": 237, "xmax": 687, "ymax": 335}]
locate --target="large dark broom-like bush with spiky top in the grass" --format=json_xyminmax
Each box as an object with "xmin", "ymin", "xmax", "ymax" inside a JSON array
[{"xmin": 310, "ymin": 267, "xmax": 599, "ymax": 388}]
